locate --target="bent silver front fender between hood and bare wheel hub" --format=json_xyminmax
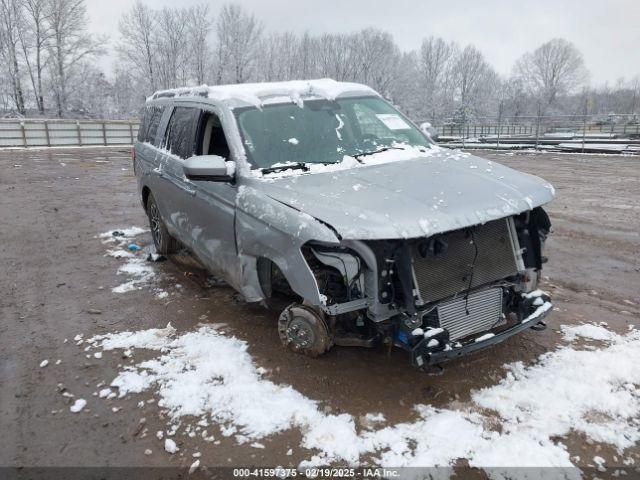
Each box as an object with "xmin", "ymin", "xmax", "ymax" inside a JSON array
[{"xmin": 236, "ymin": 186, "xmax": 340, "ymax": 305}]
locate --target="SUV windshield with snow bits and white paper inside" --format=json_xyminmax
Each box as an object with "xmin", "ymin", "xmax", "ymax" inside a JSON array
[{"xmin": 235, "ymin": 97, "xmax": 430, "ymax": 169}]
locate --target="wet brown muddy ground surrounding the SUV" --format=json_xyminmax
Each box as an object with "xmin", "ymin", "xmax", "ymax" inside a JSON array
[{"xmin": 0, "ymin": 148, "xmax": 640, "ymax": 466}]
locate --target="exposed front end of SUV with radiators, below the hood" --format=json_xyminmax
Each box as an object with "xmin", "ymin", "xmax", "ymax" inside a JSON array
[{"xmin": 308, "ymin": 207, "xmax": 551, "ymax": 367}]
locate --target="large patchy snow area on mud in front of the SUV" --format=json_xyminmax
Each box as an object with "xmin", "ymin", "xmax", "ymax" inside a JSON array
[{"xmin": 87, "ymin": 320, "xmax": 640, "ymax": 470}]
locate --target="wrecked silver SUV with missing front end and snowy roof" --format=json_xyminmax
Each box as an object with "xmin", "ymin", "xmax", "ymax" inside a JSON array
[{"xmin": 134, "ymin": 79, "xmax": 554, "ymax": 368}]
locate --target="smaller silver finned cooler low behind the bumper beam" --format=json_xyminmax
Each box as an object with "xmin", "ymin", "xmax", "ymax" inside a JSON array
[{"xmin": 437, "ymin": 288, "xmax": 502, "ymax": 340}]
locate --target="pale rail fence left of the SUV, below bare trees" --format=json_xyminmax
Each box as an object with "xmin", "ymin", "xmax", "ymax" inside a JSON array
[{"xmin": 0, "ymin": 119, "xmax": 139, "ymax": 148}]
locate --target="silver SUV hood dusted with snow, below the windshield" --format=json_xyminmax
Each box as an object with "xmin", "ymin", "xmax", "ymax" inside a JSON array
[{"xmin": 245, "ymin": 148, "xmax": 554, "ymax": 240}]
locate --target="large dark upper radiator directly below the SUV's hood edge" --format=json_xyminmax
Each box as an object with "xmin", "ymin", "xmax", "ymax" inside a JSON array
[{"xmin": 412, "ymin": 218, "xmax": 522, "ymax": 303}]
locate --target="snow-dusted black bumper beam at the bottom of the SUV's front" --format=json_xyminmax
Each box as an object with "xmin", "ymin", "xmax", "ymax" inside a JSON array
[{"xmin": 411, "ymin": 297, "xmax": 553, "ymax": 368}]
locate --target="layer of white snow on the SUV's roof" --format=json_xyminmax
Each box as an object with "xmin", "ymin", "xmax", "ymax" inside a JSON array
[{"xmin": 147, "ymin": 78, "xmax": 378, "ymax": 107}]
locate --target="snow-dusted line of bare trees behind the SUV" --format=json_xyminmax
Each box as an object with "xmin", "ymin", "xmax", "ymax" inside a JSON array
[{"xmin": 0, "ymin": 0, "xmax": 640, "ymax": 123}]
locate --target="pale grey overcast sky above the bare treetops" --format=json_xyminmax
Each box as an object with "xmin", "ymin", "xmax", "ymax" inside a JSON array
[{"xmin": 87, "ymin": 0, "xmax": 640, "ymax": 85}]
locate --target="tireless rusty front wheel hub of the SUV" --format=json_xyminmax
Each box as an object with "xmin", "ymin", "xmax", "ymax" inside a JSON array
[{"xmin": 278, "ymin": 303, "xmax": 333, "ymax": 357}]
